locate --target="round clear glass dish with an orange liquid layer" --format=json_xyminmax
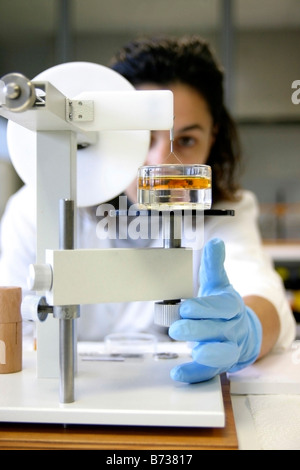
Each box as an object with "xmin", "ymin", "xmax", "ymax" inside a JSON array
[{"xmin": 138, "ymin": 164, "xmax": 212, "ymax": 210}]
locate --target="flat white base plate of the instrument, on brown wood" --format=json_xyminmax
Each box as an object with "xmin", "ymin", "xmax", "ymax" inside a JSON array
[{"xmin": 0, "ymin": 344, "xmax": 225, "ymax": 427}]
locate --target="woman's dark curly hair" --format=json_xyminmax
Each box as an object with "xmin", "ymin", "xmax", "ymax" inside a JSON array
[{"xmin": 110, "ymin": 36, "xmax": 240, "ymax": 202}]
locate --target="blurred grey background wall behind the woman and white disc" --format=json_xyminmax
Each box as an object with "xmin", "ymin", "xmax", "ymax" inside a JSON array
[{"xmin": 0, "ymin": 0, "xmax": 300, "ymax": 239}]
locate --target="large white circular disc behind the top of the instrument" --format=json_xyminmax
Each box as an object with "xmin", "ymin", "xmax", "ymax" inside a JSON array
[{"xmin": 7, "ymin": 62, "xmax": 150, "ymax": 207}]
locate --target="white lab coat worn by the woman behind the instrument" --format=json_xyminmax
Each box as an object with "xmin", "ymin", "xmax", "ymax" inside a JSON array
[{"xmin": 0, "ymin": 186, "xmax": 295, "ymax": 348}]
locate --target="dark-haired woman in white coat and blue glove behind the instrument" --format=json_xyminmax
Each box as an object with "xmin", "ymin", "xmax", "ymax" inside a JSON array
[{"xmin": 111, "ymin": 36, "xmax": 294, "ymax": 381}]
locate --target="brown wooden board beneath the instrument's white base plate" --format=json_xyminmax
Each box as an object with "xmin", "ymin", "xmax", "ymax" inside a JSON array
[{"xmin": 0, "ymin": 376, "xmax": 238, "ymax": 451}]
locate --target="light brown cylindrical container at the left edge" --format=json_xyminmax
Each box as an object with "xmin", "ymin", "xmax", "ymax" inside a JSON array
[{"xmin": 0, "ymin": 287, "xmax": 22, "ymax": 374}]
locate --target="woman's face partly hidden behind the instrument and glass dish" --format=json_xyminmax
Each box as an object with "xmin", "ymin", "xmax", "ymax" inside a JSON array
[{"xmin": 126, "ymin": 83, "xmax": 216, "ymax": 202}]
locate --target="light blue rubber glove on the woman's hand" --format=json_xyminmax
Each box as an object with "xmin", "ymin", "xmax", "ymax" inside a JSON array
[{"xmin": 169, "ymin": 239, "xmax": 262, "ymax": 383}]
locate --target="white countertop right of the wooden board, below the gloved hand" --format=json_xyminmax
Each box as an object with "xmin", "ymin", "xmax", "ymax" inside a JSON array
[{"xmin": 229, "ymin": 342, "xmax": 300, "ymax": 450}]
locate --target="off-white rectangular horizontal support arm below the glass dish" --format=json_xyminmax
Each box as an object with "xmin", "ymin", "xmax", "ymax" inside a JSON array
[{"xmin": 29, "ymin": 248, "xmax": 193, "ymax": 306}]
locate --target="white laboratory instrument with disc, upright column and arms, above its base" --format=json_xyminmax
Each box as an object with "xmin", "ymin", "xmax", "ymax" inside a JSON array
[{"xmin": 0, "ymin": 62, "xmax": 231, "ymax": 425}]
